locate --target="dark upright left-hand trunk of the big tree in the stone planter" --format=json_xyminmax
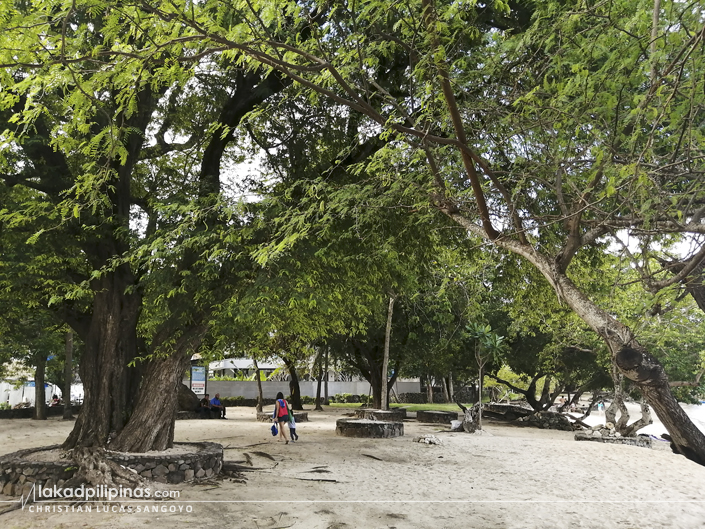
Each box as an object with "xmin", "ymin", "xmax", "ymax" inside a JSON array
[{"xmin": 63, "ymin": 267, "xmax": 141, "ymax": 449}]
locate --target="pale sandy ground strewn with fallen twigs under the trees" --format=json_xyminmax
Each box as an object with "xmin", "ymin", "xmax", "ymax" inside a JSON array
[{"xmin": 0, "ymin": 408, "xmax": 705, "ymax": 529}]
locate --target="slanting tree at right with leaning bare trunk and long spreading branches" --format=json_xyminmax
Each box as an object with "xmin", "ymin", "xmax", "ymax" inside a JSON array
[{"xmin": 129, "ymin": 0, "xmax": 705, "ymax": 462}]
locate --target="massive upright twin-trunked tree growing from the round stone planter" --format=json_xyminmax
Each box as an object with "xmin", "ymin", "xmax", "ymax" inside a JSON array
[{"xmin": 0, "ymin": 2, "xmax": 286, "ymax": 451}]
